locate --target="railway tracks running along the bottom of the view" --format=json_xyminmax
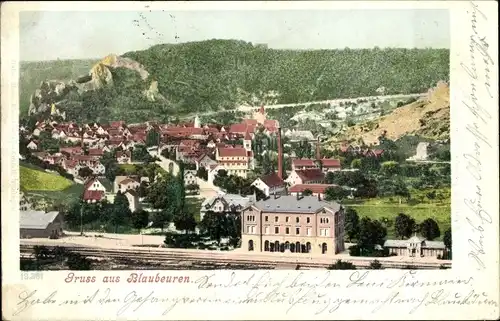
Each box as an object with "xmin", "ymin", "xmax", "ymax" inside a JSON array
[{"xmin": 20, "ymin": 244, "xmax": 451, "ymax": 269}]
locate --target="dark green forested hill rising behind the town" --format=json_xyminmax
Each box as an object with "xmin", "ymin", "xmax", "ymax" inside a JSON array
[{"xmin": 21, "ymin": 40, "xmax": 449, "ymax": 121}]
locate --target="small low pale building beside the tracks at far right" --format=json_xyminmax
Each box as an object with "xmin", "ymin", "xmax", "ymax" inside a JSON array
[{"xmin": 384, "ymin": 234, "xmax": 446, "ymax": 258}]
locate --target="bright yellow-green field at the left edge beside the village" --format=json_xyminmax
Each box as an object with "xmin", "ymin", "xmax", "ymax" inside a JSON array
[{"xmin": 19, "ymin": 166, "xmax": 74, "ymax": 191}]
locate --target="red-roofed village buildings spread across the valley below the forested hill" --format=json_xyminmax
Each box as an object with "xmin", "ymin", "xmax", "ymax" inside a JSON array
[{"xmin": 20, "ymin": 102, "xmax": 448, "ymax": 259}]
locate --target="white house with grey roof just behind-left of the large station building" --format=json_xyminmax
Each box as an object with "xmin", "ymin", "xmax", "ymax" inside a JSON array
[{"xmin": 200, "ymin": 193, "xmax": 255, "ymax": 220}]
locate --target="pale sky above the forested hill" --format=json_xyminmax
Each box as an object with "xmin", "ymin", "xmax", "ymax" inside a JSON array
[{"xmin": 19, "ymin": 9, "xmax": 450, "ymax": 61}]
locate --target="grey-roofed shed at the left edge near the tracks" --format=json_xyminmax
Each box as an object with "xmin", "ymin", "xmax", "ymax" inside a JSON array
[{"xmin": 19, "ymin": 211, "xmax": 64, "ymax": 239}]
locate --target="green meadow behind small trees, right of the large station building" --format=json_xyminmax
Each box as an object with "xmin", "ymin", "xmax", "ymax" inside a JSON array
[{"xmin": 344, "ymin": 188, "xmax": 451, "ymax": 240}]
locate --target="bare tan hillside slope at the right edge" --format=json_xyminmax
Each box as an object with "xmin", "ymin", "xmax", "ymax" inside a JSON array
[{"xmin": 331, "ymin": 82, "xmax": 450, "ymax": 145}]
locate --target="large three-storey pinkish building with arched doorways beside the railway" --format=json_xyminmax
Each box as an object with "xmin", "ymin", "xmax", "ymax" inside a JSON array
[{"xmin": 241, "ymin": 195, "xmax": 345, "ymax": 255}]
